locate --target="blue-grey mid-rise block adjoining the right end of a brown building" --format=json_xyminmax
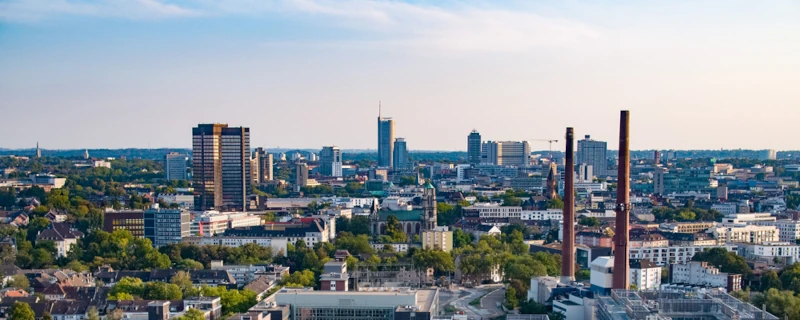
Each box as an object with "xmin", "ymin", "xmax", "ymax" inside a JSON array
[{"xmin": 144, "ymin": 205, "xmax": 192, "ymax": 247}]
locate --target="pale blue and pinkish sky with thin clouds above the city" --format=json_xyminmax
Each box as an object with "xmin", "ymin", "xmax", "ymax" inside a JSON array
[{"xmin": 0, "ymin": 0, "xmax": 800, "ymax": 150}]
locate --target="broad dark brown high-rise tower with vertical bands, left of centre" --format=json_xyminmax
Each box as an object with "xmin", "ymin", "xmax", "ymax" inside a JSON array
[{"xmin": 192, "ymin": 123, "xmax": 252, "ymax": 210}]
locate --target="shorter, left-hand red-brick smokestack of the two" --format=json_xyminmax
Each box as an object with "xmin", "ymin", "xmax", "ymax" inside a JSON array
[{"xmin": 561, "ymin": 128, "xmax": 575, "ymax": 283}]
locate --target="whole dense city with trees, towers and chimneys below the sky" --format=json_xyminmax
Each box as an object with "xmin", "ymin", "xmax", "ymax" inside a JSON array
[{"xmin": 0, "ymin": 111, "xmax": 800, "ymax": 320}]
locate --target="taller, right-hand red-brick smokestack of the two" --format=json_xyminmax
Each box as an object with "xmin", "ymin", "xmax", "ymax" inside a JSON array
[{"xmin": 612, "ymin": 110, "xmax": 631, "ymax": 290}]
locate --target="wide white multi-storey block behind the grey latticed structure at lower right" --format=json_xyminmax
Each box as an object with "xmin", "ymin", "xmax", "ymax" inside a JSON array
[{"xmin": 669, "ymin": 261, "xmax": 742, "ymax": 292}]
